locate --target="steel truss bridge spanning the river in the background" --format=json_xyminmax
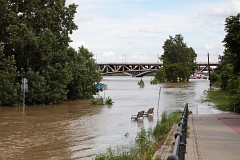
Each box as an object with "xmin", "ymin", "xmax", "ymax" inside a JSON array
[{"xmin": 98, "ymin": 62, "xmax": 218, "ymax": 77}]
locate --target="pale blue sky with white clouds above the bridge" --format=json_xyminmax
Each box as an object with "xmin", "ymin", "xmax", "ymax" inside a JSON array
[{"xmin": 66, "ymin": 0, "xmax": 240, "ymax": 63}]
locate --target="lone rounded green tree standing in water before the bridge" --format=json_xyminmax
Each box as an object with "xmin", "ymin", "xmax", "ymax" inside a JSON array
[{"xmin": 158, "ymin": 34, "xmax": 197, "ymax": 82}]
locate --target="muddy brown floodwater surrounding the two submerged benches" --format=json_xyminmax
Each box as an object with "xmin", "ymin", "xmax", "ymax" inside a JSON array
[{"xmin": 0, "ymin": 77, "xmax": 222, "ymax": 160}]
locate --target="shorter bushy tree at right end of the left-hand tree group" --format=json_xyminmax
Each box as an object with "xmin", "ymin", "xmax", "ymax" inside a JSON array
[{"xmin": 67, "ymin": 46, "xmax": 101, "ymax": 99}]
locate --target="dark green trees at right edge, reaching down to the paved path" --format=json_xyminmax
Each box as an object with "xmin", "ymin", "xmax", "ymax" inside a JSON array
[{"xmin": 212, "ymin": 13, "xmax": 240, "ymax": 113}]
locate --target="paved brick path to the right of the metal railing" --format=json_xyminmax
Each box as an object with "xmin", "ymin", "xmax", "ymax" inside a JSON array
[{"xmin": 186, "ymin": 113, "xmax": 240, "ymax": 160}]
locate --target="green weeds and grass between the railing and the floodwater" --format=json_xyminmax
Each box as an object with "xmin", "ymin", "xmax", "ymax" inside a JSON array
[{"xmin": 95, "ymin": 112, "xmax": 181, "ymax": 160}]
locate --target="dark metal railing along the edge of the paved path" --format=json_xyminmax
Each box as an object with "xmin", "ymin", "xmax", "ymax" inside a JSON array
[{"xmin": 167, "ymin": 103, "xmax": 189, "ymax": 160}]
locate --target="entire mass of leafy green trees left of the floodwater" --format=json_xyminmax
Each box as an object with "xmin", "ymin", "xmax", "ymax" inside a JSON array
[{"xmin": 0, "ymin": 0, "xmax": 101, "ymax": 105}]
